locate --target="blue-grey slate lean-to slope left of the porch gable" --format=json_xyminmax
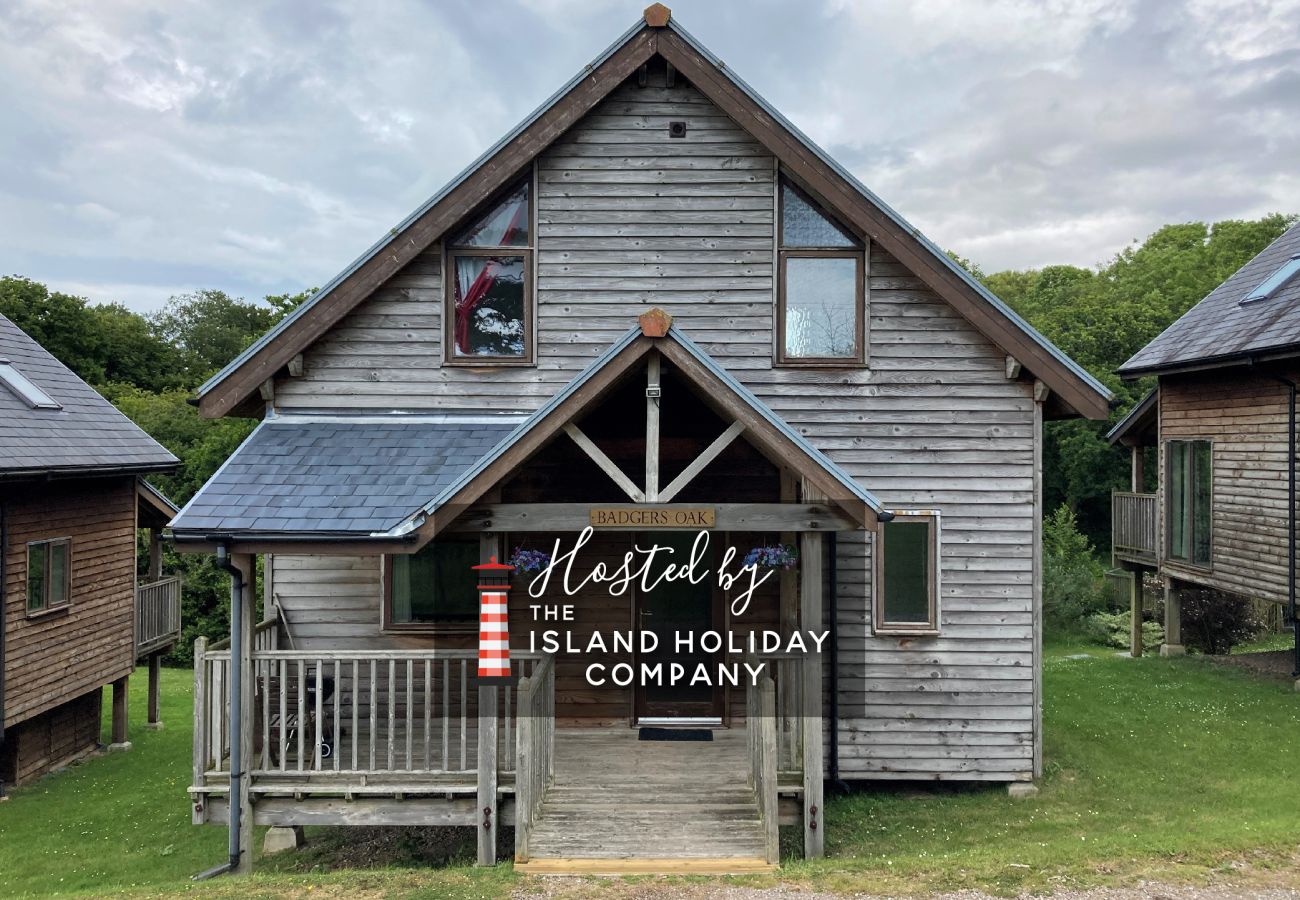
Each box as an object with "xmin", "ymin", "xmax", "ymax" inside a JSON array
[{"xmin": 172, "ymin": 415, "xmax": 519, "ymax": 540}]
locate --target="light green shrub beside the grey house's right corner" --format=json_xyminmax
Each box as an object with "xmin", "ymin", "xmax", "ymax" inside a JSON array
[{"xmin": 1043, "ymin": 506, "xmax": 1110, "ymax": 631}]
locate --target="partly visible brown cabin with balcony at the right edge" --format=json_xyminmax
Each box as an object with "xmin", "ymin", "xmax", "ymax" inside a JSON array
[{"xmin": 1108, "ymin": 225, "xmax": 1300, "ymax": 660}]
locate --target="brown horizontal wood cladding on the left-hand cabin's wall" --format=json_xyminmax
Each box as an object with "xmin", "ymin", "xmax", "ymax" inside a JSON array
[{"xmin": 4, "ymin": 477, "xmax": 135, "ymax": 727}]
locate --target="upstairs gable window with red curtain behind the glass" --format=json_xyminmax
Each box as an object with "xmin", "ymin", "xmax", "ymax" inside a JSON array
[{"xmin": 446, "ymin": 179, "xmax": 534, "ymax": 365}]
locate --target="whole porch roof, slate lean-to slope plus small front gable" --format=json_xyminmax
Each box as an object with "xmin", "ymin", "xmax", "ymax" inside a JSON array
[{"xmin": 172, "ymin": 313, "xmax": 891, "ymax": 550}]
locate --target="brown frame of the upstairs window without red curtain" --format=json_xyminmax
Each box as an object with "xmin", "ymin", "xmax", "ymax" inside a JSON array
[{"xmin": 772, "ymin": 174, "xmax": 871, "ymax": 368}]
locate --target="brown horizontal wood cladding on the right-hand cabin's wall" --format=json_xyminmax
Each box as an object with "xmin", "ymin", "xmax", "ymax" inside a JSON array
[{"xmin": 1160, "ymin": 368, "xmax": 1300, "ymax": 602}]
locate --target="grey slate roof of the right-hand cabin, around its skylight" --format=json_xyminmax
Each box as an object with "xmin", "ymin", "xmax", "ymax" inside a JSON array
[{"xmin": 1118, "ymin": 225, "xmax": 1300, "ymax": 377}]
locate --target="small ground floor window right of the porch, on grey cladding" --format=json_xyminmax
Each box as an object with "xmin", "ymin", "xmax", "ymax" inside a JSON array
[{"xmin": 875, "ymin": 511, "xmax": 939, "ymax": 633}]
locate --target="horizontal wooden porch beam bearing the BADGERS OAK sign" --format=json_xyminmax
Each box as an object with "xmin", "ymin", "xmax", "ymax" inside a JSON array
[{"xmin": 447, "ymin": 503, "xmax": 858, "ymax": 532}]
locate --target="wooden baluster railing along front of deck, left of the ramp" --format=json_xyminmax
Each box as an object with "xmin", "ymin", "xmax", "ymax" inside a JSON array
[{"xmin": 194, "ymin": 642, "xmax": 538, "ymax": 786}]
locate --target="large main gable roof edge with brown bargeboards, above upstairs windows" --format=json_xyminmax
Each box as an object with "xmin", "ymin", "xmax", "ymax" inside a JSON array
[{"xmin": 199, "ymin": 4, "xmax": 1110, "ymax": 419}]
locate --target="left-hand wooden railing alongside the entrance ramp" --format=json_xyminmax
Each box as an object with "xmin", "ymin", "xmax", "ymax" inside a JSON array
[{"xmin": 515, "ymin": 655, "xmax": 555, "ymax": 862}]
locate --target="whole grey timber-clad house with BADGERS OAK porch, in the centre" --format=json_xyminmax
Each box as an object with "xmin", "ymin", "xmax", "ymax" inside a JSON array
[{"xmin": 172, "ymin": 4, "xmax": 1109, "ymax": 871}]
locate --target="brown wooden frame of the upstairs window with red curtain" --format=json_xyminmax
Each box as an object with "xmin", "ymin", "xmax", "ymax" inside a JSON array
[{"xmin": 441, "ymin": 166, "xmax": 537, "ymax": 368}]
